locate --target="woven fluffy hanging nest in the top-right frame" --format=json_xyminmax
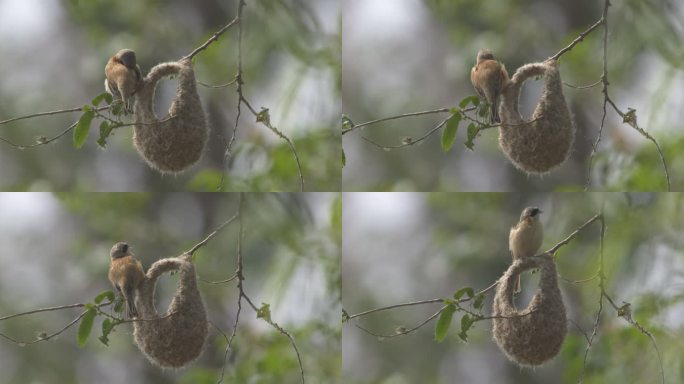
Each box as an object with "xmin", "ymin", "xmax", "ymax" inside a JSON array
[{"xmin": 499, "ymin": 60, "xmax": 575, "ymax": 174}]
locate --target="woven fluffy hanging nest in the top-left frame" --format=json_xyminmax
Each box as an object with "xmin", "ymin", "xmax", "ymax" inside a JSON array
[{"xmin": 133, "ymin": 59, "xmax": 207, "ymax": 173}]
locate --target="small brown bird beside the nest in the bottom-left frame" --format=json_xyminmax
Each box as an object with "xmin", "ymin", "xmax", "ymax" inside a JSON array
[{"xmin": 109, "ymin": 243, "xmax": 145, "ymax": 319}]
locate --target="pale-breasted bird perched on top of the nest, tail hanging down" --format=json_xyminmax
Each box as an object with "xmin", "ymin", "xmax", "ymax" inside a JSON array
[{"xmin": 508, "ymin": 207, "xmax": 544, "ymax": 293}]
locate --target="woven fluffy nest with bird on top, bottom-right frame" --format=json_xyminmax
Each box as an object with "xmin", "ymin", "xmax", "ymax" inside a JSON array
[{"xmin": 492, "ymin": 255, "xmax": 567, "ymax": 366}]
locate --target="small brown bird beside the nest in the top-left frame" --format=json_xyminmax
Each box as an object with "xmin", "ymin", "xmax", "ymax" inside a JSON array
[{"xmin": 105, "ymin": 49, "xmax": 142, "ymax": 113}]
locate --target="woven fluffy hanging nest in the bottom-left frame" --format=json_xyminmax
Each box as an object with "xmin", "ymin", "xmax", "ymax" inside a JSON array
[{"xmin": 133, "ymin": 256, "xmax": 208, "ymax": 368}]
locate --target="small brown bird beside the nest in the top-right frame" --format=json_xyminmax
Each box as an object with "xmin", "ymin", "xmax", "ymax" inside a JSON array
[{"xmin": 470, "ymin": 49, "xmax": 508, "ymax": 124}]
